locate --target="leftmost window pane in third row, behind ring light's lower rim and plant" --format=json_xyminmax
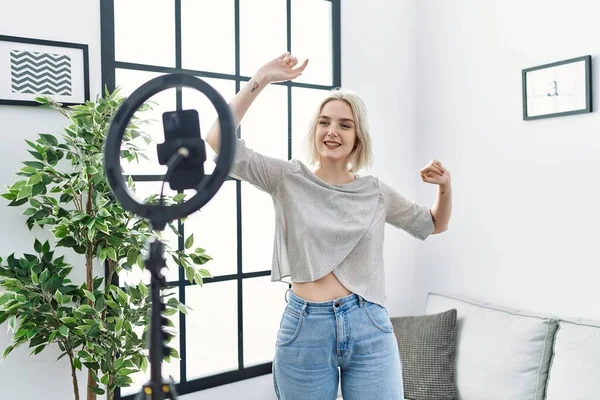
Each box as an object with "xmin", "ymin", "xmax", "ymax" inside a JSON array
[{"xmin": 119, "ymin": 181, "xmax": 179, "ymax": 285}]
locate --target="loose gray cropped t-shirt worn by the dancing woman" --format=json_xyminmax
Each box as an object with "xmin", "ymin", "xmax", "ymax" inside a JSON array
[{"xmin": 215, "ymin": 139, "xmax": 434, "ymax": 307}]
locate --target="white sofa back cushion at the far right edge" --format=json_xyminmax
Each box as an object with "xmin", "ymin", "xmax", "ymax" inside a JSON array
[{"xmin": 546, "ymin": 320, "xmax": 600, "ymax": 400}]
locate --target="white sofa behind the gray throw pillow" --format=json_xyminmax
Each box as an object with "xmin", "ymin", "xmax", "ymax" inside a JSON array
[{"xmin": 338, "ymin": 293, "xmax": 600, "ymax": 400}]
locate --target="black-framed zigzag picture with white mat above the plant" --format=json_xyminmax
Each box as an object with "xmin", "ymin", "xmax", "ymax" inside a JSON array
[{"xmin": 0, "ymin": 35, "xmax": 90, "ymax": 105}]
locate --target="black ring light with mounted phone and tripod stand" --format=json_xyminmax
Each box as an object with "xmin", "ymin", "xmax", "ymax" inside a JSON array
[{"xmin": 105, "ymin": 74, "xmax": 235, "ymax": 400}]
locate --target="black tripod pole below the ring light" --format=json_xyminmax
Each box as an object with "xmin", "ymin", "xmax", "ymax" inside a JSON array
[{"xmin": 136, "ymin": 239, "xmax": 177, "ymax": 400}]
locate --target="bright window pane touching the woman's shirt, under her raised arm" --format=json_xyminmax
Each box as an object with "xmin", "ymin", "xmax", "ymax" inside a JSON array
[{"xmin": 242, "ymin": 182, "xmax": 275, "ymax": 272}]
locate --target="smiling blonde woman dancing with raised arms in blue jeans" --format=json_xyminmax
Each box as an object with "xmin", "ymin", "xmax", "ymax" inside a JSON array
[{"xmin": 206, "ymin": 52, "xmax": 451, "ymax": 400}]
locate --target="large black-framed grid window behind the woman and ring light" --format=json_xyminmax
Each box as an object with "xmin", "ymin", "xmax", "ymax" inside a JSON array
[{"xmin": 101, "ymin": 0, "xmax": 341, "ymax": 400}]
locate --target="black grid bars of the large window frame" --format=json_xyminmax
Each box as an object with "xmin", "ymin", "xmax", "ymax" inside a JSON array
[{"xmin": 100, "ymin": 0, "xmax": 341, "ymax": 400}]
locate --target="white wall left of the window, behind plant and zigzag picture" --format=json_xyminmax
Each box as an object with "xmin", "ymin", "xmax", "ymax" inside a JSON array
[{"xmin": 0, "ymin": 0, "xmax": 101, "ymax": 400}]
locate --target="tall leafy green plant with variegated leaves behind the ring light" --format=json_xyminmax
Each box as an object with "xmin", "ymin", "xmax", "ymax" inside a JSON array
[{"xmin": 0, "ymin": 89, "xmax": 211, "ymax": 400}]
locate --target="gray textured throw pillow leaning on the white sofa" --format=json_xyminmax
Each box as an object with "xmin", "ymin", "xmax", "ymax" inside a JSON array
[{"xmin": 391, "ymin": 309, "xmax": 458, "ymax": 400}]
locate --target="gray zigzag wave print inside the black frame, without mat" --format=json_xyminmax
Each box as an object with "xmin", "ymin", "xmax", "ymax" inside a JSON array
[{"xmin": 10, "ymin": 50, "xmax": 72, "ymax": 96}]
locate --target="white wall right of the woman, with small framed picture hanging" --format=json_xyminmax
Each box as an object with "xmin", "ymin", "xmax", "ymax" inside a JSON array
[{"xmin": 415, "ymin": 0, "xmax": 600, "ymax": 319}]
